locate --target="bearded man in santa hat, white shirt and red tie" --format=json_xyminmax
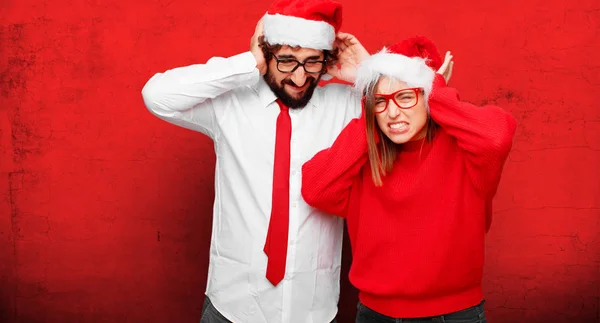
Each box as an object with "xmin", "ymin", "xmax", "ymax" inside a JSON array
[{"xmin": 142, "ymin": 0, "xmax": 369, "ymax": 323}]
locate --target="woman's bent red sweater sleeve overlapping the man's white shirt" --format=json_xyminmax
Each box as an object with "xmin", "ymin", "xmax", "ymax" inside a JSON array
[{"xmin": 302, "ymin": 117, "xmax": 368, "ymax": 217}]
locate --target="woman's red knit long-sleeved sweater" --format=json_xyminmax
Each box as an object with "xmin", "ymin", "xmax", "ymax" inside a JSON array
[{"xmin": 302, "ymin": 74, "xmax": 516, "ymax": 318}]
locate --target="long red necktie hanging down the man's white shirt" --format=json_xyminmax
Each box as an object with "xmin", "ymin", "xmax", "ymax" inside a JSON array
[{"xmin": 264, "ymin": 100, "xmax": 292, "ymax": 286}]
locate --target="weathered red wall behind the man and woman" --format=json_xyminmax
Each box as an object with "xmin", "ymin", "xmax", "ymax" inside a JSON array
[{"xmin": 0, "ymin": 0, "xmax": 600, "ymax": 323}]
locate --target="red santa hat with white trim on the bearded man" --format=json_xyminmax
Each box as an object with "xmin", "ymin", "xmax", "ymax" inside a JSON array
[{"xmin": 263, "ymin": 0, "xmax": 342, "ymax": 50}]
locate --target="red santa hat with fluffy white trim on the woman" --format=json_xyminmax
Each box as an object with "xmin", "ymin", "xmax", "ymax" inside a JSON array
[{"xmin": 354, "ymin": 36, "xmax": 443, "ymax": 98}]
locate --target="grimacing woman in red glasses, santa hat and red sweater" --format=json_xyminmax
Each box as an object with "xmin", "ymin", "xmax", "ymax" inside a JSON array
[{"xmin": 302, "ymin": 38, "xmax": 516, "ymax": 323}]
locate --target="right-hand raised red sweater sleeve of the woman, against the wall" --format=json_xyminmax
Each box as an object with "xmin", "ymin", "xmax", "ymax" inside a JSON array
[{"xmin": 429, "ymin": 73, "xmax": 516, "ymax": 199}]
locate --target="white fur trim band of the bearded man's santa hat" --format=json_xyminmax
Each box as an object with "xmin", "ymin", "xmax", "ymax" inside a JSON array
[{"xmin": 263, "ymin": 14, "xmax": 335, "ymax": 50}]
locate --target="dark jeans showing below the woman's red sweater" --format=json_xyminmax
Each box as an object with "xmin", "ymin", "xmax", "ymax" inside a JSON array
[{"xmin": 356, "ymin": 301, "xmax": 487, "ymax": 323}]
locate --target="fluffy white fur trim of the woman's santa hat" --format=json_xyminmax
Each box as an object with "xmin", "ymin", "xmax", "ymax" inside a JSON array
[{"xmin": 354, "ymin": 47, "xmax": 435, "ymax": 99}]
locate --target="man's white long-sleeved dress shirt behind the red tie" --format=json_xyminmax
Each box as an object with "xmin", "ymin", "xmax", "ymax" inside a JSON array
[{"xmin": 142, "ymin": 52, "xmax": 361, "ymax": 323}]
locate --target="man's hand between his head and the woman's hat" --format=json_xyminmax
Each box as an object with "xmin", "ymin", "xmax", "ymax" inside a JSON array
[{"xmin": 327, "ymin": 32, "xmax": 370, "ymax": 83}]
